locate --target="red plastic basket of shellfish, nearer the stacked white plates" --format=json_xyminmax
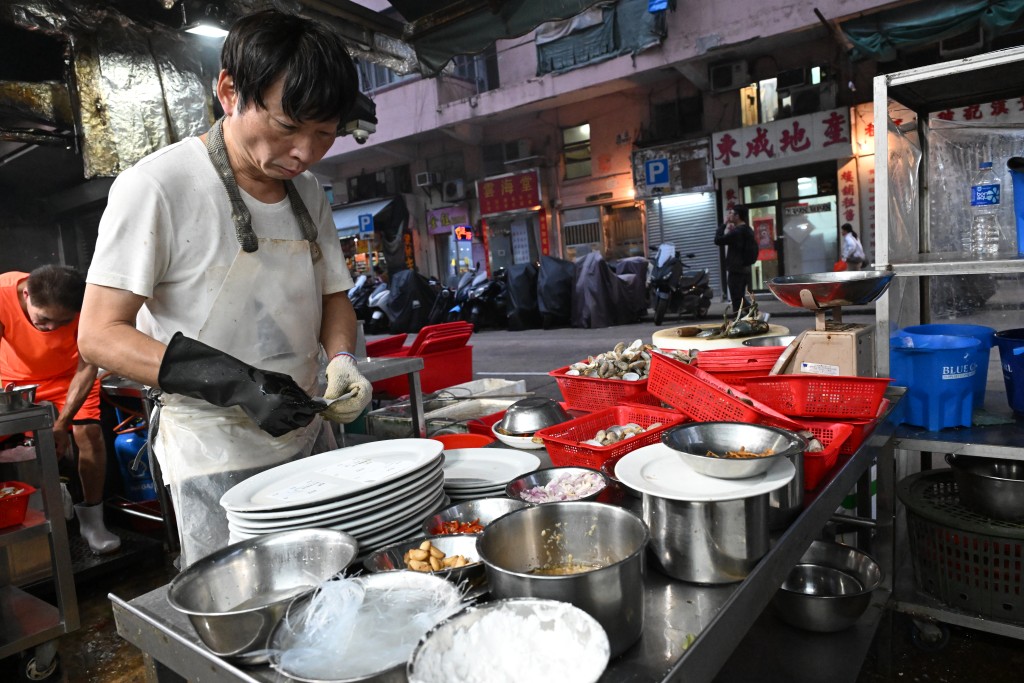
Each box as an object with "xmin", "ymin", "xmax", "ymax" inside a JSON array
[{"xmin": 537, "ymin": 405, "xmax": 686, "ymax": 470}]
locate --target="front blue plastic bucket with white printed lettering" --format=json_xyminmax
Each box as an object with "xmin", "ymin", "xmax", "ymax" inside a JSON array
[{"xmin": 889, "ymin": 330, "xmax": 981, "ymax": 431}]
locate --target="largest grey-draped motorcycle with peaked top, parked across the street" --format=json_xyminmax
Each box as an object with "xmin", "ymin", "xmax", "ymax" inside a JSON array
[{"xmin": 571, "ymin": 252, "xmax": 636, "ymax": 328}]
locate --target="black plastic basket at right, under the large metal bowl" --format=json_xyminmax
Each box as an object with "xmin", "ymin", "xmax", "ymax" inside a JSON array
[{"xmin": 896, "ymin": 469, "xmax": 1024, "ymax": 623}]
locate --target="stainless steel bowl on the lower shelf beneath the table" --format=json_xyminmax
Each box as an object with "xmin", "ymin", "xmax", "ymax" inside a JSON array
[{"xmin": 771, "ymin": 541, "xmax": 882, "ymax": 633}]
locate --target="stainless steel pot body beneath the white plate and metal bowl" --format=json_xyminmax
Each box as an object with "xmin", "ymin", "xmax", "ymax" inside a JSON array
[{"xmin": 643, "ymin": 494, "xmax": 769, "ymax": 584}]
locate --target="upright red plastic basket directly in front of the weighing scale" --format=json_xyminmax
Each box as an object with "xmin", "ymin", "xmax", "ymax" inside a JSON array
[{"xmin": 746, "ymin": 375, "xmax": 891, "ymax": 420}]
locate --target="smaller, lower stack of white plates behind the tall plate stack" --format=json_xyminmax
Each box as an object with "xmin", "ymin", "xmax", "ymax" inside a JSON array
[{"xmin": 443, "ymin": 449, "xmax": 541, "ymax": 502}]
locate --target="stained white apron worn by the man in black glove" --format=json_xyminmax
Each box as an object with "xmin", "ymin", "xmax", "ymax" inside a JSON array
[{"xmin": 155, "ymin": 122, "xmax": 336, "ymax": 569}]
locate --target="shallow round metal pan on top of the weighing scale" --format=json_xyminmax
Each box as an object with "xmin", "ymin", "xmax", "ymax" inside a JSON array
[{"xmin": 768, "ymin": 270, "xmax": 895, "ymax": 310}]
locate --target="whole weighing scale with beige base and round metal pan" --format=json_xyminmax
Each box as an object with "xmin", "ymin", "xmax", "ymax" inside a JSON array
[{"xmin": 768, "ymin": 270, "xmax": 894, "ymax": 377}]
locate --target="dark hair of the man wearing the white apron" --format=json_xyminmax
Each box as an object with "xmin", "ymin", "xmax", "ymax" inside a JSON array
[{"xmin": 220, "ymin": 9, "xmax": 359, "ymax": 126}]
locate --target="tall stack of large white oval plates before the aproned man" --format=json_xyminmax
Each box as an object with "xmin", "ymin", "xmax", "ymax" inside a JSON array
[{"xmin": 220, "ymin": 438, "xmax": 451, "ymax": 555}]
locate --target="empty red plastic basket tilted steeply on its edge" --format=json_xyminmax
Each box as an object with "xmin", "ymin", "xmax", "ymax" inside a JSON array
[{"xmin": 648, "ymin": 353, "xmax": 802, "ymax": 431}]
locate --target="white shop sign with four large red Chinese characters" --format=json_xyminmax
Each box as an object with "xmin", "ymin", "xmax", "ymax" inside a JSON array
[{"xmin": 712, "ymin": 108, "xmax": 852, "ymax": 175}]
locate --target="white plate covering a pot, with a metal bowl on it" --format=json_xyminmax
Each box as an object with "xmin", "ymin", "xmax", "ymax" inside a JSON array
[{"xmin": 615, "ymin": 443, "xmax": 797, "ymax": 502}]
